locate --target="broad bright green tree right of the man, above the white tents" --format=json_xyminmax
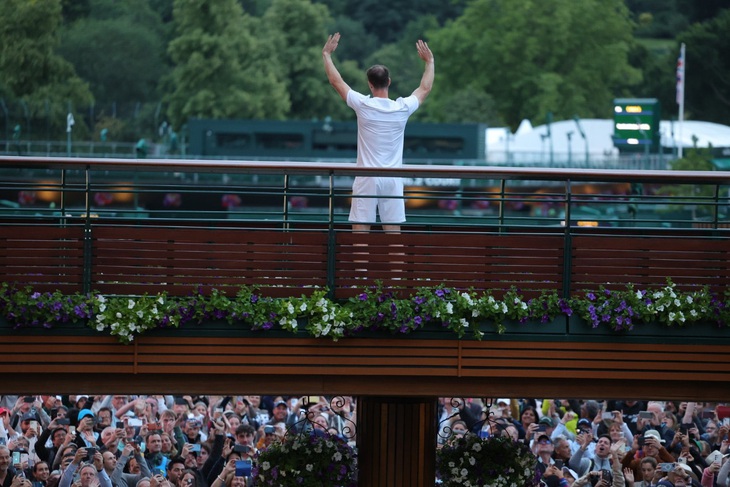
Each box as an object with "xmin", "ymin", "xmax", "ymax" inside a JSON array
[{"xmin": 428, "ymin": 0, "xmax": 640, "ymax": 128}]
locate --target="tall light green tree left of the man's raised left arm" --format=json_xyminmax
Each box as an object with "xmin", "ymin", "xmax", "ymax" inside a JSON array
[{"xmin": 165, "ymin": 0, "xmax": 290, "ymax": 128}]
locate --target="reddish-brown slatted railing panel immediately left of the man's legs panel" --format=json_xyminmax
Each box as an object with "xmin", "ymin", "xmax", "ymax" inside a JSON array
[{"xmin": 92, "ymin": 227, "xmax": 327, "ymax": 296}]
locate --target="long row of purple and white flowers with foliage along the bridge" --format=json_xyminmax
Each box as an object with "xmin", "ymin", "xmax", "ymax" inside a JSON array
[{"xmin": 0, "ymin": 280, "xmax": 730, "ymax": 343}]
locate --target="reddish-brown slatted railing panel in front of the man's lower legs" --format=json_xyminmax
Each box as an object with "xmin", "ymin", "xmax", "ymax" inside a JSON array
[{"xmin": 335, "ymin": 233, "xmax": 564, "ymax": 298}]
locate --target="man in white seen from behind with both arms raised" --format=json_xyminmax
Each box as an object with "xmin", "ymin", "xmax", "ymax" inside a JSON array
[{"xmin": 322, "ymin": 32, "xmax": 434, "ymax": 233}]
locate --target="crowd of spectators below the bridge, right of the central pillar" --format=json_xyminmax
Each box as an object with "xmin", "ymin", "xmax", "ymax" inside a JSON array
[{"xmin": 438, "ymin": 397, "xmax": 730, "ymax": 487}]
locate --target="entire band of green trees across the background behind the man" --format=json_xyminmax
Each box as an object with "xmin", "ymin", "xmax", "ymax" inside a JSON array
[{"xmin": 0, "ymin": 0, "xmax": 730, "ymax": 139}]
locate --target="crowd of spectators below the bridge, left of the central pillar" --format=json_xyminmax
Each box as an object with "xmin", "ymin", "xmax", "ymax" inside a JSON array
[{"xmin": 0, "ymin": 394, "xmax": 356, "ymax": 487}]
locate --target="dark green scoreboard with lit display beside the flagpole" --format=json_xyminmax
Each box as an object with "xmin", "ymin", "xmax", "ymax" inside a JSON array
[{"xmin": 613, "ymin": 98, "xmax": 661, "ymax": 153}]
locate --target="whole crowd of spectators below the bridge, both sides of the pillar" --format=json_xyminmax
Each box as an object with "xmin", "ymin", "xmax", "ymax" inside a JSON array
[{"xmin": 0, "ymin": 394, "xmax": 730, "ymax": 487}]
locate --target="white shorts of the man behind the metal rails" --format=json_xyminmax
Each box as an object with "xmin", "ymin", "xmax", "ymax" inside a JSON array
[{"xmin": 350, "ymin": 177, "xmax": 406, "ymax": 224}]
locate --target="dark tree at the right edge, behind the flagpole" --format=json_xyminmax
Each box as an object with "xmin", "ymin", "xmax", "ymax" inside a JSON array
[{"xmin": 674, "ymin": 9, "xmax": 730, "ymax": 124}]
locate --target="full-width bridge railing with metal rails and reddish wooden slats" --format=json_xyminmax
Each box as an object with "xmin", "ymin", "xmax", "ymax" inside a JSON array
[{"xmin": 0, "ymin": 157, "xmax": 730, "ymax": 298}]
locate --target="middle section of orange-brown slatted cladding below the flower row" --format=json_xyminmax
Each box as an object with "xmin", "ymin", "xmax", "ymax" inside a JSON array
[{"xmin": 137, "ymin": 337, "xmax": 458, "ymax": 376}]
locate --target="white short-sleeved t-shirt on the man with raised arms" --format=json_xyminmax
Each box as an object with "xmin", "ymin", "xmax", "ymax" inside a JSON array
[{"xmin": 347, "ymin": 90, "xmax": 418, "ymax": 167}]
